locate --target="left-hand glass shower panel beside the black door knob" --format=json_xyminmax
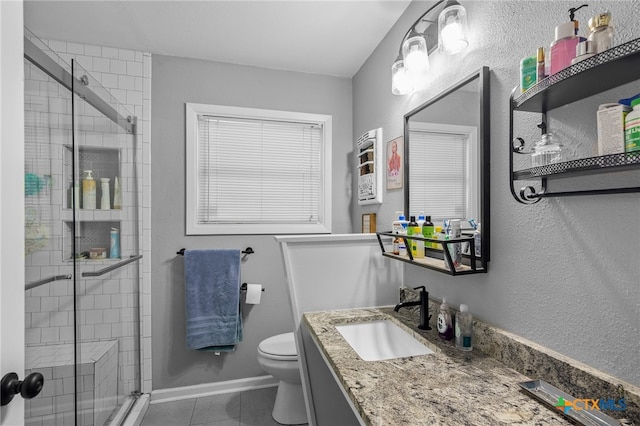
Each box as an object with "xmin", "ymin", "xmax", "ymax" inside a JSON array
[{"xmin": 24, "ymin": 33, "xmax": 75, "ymax": 425}]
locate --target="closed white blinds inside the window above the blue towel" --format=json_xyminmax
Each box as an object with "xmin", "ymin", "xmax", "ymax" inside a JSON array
[{"xmin": 197, "ymin": 115, "xmax": 323, "ymax": 224}]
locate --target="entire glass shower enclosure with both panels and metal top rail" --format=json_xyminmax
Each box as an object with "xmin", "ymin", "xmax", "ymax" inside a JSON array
[{"xmin": 24, "ymin": 31, "xmax": 142, "ymax": 426}]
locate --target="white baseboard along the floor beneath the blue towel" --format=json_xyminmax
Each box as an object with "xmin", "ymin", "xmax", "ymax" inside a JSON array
[{"xmin": 150, "ymin": 375, "xmax": 279, "ymax": 404}]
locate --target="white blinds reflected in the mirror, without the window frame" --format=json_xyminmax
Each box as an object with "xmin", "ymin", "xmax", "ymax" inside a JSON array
[{"xmin": 409, "ymin": 130, "xmax": 469, "ymax": 221}]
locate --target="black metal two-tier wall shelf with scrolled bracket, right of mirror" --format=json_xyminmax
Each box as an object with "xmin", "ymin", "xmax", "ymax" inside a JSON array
[{"xmin": 509, "ymin": 39, "xmax": 640, "ymax": 204}]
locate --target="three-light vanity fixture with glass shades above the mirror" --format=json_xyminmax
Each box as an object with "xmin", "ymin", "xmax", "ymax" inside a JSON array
[{"xmin": 391, "ymin": 0, "xmax": 469, "ymax": 95}]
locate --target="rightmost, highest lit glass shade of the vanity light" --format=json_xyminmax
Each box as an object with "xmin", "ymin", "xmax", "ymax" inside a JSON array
[{"xmin": 438, "ymin": 1, "xmax": 469, "ymax": 55}]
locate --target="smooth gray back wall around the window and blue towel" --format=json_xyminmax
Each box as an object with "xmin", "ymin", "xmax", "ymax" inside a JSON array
[{"xmin": 151, "ymin": 55, "xmax": 352, "ymax": 389}]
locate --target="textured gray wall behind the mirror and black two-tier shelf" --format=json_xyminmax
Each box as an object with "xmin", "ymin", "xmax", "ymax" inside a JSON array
[{"xmin": 352, "ymin": 1, "xmax": 640, "ymax": 385}]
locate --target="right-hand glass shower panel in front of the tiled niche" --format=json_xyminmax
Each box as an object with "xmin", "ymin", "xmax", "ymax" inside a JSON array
[{"xmin": 71, "ymin": 60, "xmax": 141, "ymax": 425}]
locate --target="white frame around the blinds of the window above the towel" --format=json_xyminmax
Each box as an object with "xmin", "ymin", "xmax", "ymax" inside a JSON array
[{"xmin": 185, "ymin": 103, "xmax": 332, "ymax": 235}]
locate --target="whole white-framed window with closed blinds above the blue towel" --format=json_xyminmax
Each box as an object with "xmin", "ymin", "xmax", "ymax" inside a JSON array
[{"xmin": 186, "ymin": 103, "xmax": 331, "ymax": 235}]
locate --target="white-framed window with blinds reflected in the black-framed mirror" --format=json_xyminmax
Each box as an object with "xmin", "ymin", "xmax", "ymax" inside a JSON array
[{"xmin": 409, "ymin": 123, "xmax": 480, "ymax": 223}]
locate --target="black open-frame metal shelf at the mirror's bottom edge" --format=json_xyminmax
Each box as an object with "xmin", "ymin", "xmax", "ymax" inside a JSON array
[{"xmin": 376, "ymin": 232, "xmax": 487, "ymax": 275}]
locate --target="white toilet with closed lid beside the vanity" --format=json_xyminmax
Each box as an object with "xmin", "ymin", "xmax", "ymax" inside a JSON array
[{"xmin": 258, "ymin": 333, "xmax": 308, "ymax": 425}]
